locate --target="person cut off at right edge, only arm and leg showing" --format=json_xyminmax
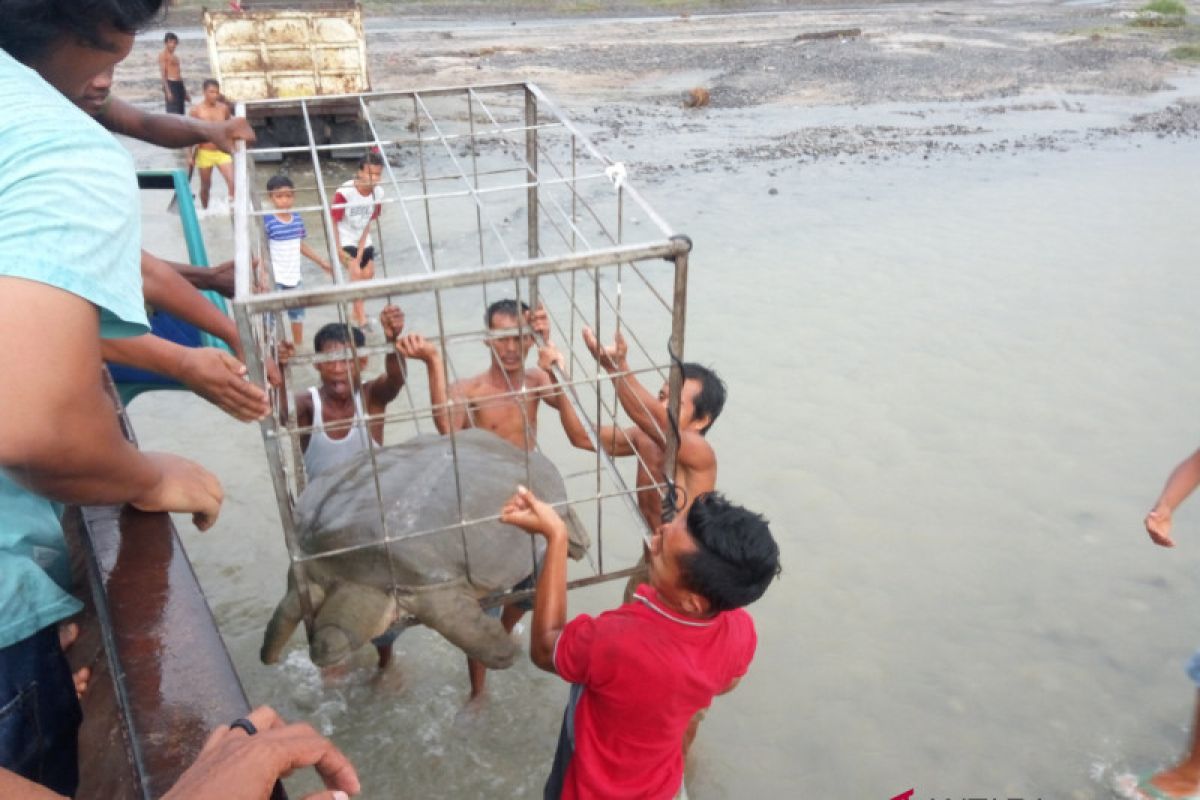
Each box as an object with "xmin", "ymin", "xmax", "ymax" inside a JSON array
[{"xmin": 1132, "ymin": 450, "xmax": 1200, "ymax": 800}]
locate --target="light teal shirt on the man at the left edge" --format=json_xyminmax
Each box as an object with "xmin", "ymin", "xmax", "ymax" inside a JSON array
[{"xmin": 0, "ymin": 50, "xmax": 148, "ymax": 648}]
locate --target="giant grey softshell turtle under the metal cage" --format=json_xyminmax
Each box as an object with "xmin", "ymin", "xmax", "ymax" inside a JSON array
[{"xmin": 260, "ymin": 429, "xmax": 588, "ymax": 669}]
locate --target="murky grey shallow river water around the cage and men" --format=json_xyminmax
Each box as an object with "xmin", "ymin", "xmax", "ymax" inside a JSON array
[{"xmin": 132, "ymin": 84, "xmax": 1200, "ymax": 800}]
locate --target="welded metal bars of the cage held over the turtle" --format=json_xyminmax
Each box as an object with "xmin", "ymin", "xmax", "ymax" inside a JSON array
[{"xmin": 233, "ymin": 82, "xmax": 691, "ymax": 637}]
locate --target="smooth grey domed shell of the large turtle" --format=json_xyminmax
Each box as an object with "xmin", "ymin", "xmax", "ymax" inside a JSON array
[{"xmin": 296, "ymin": 428, "xmax": 566, "ymax": 594}]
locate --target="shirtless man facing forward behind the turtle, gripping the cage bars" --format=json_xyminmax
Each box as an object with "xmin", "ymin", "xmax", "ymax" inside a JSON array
[{"xmin": 396, "ymin": 300, "xmax": 565, "ymax": 700}]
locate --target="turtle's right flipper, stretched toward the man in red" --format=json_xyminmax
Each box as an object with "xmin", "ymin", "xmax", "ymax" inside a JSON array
[{"xmin": 406, "ymin": 582, "xmax": 517, "ymax": 669}]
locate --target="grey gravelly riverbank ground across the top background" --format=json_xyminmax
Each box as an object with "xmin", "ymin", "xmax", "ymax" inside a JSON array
[{"xmin": 118, "ymin": 0, "xmax": 1200, "ymax": 163}]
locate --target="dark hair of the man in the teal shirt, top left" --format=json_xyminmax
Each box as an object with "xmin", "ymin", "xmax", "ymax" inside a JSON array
[{"xmin": 0, "ymin": 0, "xmax": 164, "ymax": 66}]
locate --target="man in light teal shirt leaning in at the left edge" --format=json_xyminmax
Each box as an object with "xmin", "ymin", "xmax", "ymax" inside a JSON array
[{"xmin": 0, "ymin": 0, "xmax": 222, "ymax": 795}]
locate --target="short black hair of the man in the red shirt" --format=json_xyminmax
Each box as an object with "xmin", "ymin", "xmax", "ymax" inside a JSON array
[{"xmin": 679, "ymin": 492, "xmax": 779, "ymax": 612}]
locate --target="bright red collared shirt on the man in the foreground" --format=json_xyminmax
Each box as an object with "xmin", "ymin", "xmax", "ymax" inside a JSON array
[{"xmin": 554, "ymin": 584, "xmax": 757, "ymax": 800}]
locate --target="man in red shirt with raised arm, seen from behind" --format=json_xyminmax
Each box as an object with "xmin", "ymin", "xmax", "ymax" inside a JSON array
[{"xmin": 500, "ymin": 487, "xmax": 779, "ymax": 800}]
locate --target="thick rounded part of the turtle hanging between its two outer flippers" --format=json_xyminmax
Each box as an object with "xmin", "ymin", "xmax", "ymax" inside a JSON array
[{"xmin": 308, "ymin": 583, "xmax": 396, "ymax": 667}]
